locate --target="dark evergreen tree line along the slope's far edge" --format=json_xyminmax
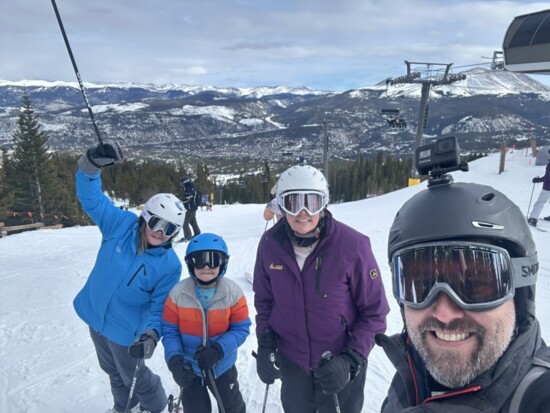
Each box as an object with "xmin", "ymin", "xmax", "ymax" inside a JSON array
[{"xmin": 0, "ymin": 95, "xmax": 481, "ymax": 226}]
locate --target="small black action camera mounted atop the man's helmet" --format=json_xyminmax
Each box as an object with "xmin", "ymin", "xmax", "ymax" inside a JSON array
[{"xmin": 415, "ymin": 136, "xmax": 469, "ymax": 187}]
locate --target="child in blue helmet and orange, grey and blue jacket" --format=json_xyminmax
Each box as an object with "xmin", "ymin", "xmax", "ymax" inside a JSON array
[{"xmin": 162, "ymin": 233, "xmax": 251, "ymax": 413}]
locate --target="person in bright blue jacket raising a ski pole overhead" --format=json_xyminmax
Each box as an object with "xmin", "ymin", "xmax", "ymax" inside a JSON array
[{"xmin": 73, "ymin": 144, "xmax": 185, "ymax": 413}]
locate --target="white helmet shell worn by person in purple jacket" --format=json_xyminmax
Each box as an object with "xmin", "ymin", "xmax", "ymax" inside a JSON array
[{"xmin": 277, "ymin": 165, "xmax": 329, "ymax": 200}]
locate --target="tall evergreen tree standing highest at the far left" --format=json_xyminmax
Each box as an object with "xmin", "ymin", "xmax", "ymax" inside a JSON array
[{"xmin": 5, "ymin": 94, "xmax": 57, "ymax": 221}]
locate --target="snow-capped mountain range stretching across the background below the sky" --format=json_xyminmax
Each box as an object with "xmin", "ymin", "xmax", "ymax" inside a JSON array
[{"xmin": 0, "ymin": 68, "xmax": 550, "ymax": 169}]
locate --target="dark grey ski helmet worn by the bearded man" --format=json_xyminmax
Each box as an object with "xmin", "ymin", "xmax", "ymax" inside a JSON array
[{"xmin": 388, "ymin": 182, "xmax": 538, "ymax": 324}]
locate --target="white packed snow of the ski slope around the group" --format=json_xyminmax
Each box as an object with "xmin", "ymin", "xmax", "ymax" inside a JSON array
[{"xmin": 0, "ymin": 150, "xmax": 550, "ymax": 413}]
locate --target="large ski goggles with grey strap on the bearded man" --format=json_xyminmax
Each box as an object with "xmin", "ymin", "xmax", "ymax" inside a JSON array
[{"xmin": 391, "ymin": 241, "xmax": 538, "ymax": 310}]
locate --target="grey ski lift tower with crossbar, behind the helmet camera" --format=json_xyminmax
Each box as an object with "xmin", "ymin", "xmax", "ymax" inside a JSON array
[{"xmin": 386, "ymin": 60, "xmax": 466, "ymax": 177}]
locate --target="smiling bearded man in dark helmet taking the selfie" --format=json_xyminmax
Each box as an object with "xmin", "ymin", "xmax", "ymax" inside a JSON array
[{"xmin": 376, "ymin": 183, "xmax": 550, "ymax": 413}]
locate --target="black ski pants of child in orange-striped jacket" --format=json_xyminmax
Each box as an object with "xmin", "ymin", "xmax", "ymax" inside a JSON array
[{"xmin": 182, "ymin": 366, "xmax": 246, "ymax": 413}]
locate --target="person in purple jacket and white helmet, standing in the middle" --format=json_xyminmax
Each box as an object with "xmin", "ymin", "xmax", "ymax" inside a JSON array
[{"xmin": 254, "ymin": 165, "xmax": 389, "ymax": 413}]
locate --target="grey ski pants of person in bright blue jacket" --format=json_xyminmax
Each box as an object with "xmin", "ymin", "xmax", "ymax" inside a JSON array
[{"xmin": 90, "ymin": 328, "xmax": 168, "ymax": 413}]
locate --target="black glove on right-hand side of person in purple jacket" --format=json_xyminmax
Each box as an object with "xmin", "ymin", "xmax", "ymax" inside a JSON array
[{"xmin": 313, "ymin": 349, "xmax": 363, "ymax": 394}]
